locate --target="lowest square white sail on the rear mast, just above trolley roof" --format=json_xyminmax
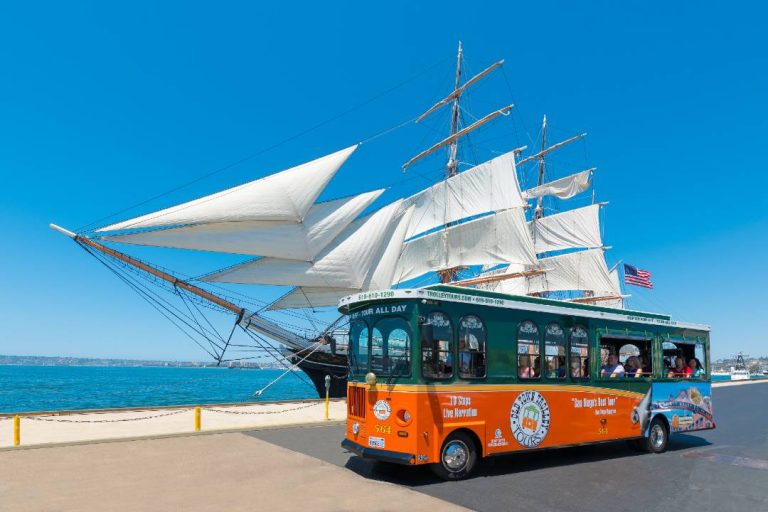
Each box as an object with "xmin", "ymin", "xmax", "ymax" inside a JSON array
[{"xmin": 527, "ymin": 249, "xmax": 613, "ymax": 293}]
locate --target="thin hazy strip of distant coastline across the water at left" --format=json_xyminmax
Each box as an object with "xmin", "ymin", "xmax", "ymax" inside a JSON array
[{"xmin": 0, "ymin": 354, "xmax": 285, "ymax": 369}]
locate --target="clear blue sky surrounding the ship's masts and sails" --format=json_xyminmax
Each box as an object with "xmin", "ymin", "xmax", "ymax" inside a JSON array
[{"xmin": 0, "ymin": 1, "xmax": 768, "ymax": 359}]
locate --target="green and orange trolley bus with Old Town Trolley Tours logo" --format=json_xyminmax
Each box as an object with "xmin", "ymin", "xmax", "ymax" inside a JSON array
[{"xmin": 339, "ymin": 285, "xmax": 715, "ymax": 480}]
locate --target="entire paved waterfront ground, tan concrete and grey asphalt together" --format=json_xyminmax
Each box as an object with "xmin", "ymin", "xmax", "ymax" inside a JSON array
[{"xmin": 0, "ymin": 381, "xmax": 768, "ymax": 512}]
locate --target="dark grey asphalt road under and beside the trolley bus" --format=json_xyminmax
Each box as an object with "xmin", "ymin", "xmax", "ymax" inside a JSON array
[{"xmin": 248, "ymin": 384, "xmax": 768, "ymax": 512}]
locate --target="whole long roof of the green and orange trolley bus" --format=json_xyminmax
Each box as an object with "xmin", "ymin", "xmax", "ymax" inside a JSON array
[{"xmin": 339, "ymin": 285, "xmax": 710, "ymax": 332}]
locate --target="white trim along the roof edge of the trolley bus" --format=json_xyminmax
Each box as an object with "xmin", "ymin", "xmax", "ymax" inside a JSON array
[{"xmin": 339, "ymin": 288, "xmax": 711, "ymax": 332}]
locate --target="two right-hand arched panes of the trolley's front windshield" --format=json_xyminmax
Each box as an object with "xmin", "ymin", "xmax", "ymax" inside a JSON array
[{"xmin": 371, "ymin": 317, "xmax": 411, "ymax": 376}]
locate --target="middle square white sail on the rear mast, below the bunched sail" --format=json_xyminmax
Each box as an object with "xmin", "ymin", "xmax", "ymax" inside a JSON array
[{"xmin": 530, "ymin": 204, "xmax": 603, "ymax": 254}]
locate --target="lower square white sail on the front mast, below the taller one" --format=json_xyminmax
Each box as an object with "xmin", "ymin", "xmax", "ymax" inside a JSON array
[{"xmin": 395, "ymin": 208, "xmax": 536, "ymax": 282}]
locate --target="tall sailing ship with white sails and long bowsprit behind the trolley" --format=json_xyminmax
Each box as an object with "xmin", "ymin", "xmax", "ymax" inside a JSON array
[{"xmin": 51, "ymin": 44, "xmax": 626, "ymax": 396}]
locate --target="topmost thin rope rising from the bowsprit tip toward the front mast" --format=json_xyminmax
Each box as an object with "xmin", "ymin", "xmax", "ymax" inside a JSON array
[{"xmin": 76, "ymin": 59, "xmax": 447, "ymax": 232}]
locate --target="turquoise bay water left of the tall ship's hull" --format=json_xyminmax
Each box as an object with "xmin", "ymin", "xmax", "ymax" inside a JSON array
[{"xmin": 0, "ymin": 366, "xmax": 317, "ymax": 412}]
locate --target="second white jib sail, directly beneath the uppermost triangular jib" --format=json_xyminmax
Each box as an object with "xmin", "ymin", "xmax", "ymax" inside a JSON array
[{"xmin": 102, "ymin": 189, "xmax": 384, "ymax": 261}]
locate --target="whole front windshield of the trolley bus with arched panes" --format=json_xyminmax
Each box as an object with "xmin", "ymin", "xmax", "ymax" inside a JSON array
[{"xmin": 349, "ymin": 316, "xmax": 412, "ymax": 377}]
